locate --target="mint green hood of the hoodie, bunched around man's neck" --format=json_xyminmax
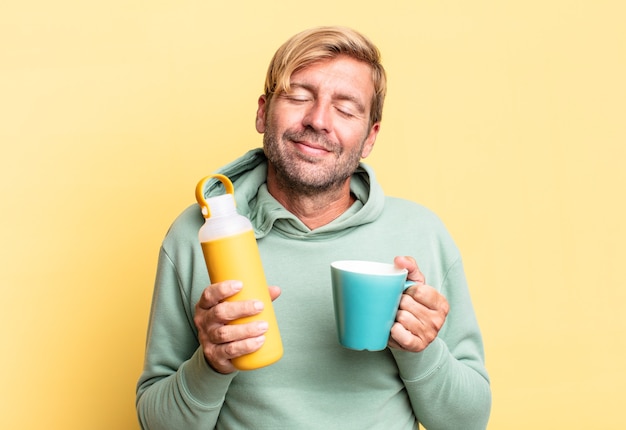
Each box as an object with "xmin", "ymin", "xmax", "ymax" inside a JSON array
[{"xmin": 204, "ymin": 148, "xmax": 385, "ymax": 239}]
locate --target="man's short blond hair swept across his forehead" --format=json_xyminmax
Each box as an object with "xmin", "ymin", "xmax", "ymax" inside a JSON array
[{"xmin": 265, "ymin": 27, "xmax": 387, "ymax": 125}]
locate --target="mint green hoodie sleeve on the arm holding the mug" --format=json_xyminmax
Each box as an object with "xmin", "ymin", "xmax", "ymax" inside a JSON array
[{"xmin": 391, "ymin": 259, "xmax": 491, "ymax": 430}]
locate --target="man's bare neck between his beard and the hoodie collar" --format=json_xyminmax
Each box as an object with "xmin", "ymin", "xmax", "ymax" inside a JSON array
[{"xmin": 267, "ymin": 167, "xmax": 356, "ymax": 230}]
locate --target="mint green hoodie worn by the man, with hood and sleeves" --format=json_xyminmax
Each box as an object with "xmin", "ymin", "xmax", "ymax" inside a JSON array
[{"xmin": 137, "ymin": 149, "xmax": 491, "ymax": 430}]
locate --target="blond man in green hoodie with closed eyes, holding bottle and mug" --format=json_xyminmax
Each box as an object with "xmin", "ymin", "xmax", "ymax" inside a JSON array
[{"xmin": 137, "ymin": 27, "xmax": 491, "ymax": 430}]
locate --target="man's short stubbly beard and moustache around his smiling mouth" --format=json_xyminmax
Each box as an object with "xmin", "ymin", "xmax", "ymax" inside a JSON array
[{"xmin": 263, "ymin": 124, "xmax": 364, "ymax": 195}]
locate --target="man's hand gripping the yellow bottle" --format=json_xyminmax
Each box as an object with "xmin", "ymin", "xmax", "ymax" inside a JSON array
[{"xmin": 193, "ymin": 281, "xmax": 280, "ymax": 374}]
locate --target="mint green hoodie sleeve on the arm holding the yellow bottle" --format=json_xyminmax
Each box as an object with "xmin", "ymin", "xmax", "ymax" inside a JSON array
[{"xmin": 137, "ymin": 248, "xmax": 235, "ymax": 430}]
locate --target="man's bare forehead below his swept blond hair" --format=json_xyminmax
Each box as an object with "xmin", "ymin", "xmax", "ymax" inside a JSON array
[{"xmin": 290, "ymin": 55, "xmax": 374, "ymax": 103}]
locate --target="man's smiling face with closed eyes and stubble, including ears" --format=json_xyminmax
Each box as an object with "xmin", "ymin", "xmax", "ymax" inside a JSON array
[{"xmin": 256, "ymin": 56, "xmax": 380, "ymax": 193}]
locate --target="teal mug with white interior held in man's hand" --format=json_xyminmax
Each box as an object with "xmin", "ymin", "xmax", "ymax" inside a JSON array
[{"xmin": 330, "ymin": 260, "xmax": 415, "ymax": 351}]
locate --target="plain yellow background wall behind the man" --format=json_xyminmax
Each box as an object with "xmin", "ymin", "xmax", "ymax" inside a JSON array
[{"xmin": 0, "ymin": 0, "xmax": 626, "ymax": 430}]
